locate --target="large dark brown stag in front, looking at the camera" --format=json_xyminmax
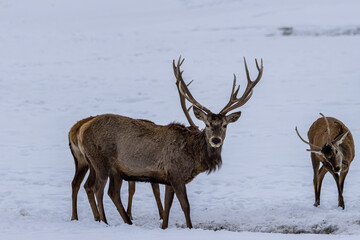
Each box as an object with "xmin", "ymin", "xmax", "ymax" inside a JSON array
[{"xmin": 77, "ymin": 57, "xmax": 263, "ymax": 229}]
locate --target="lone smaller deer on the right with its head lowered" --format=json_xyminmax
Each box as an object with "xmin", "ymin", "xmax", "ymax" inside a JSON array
[{"xmin": 295, "ymin": 113, "xmax": 355, "ymax": 209}]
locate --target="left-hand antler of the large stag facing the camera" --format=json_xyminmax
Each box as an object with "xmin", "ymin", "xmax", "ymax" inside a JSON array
[{"xmin": 173, "ymin": 56, "xmax": 210, "ymax": 128}]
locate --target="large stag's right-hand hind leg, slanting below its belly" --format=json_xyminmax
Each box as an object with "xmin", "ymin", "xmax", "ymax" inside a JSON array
[{"xmin": 108, "ymin": 174, "xmax": 132, "ymax": 225}]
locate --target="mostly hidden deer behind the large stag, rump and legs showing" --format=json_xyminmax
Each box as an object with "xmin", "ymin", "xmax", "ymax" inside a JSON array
[{"xmin": 69, "ymin": 117, "xmax": 164, "ymax": 222}]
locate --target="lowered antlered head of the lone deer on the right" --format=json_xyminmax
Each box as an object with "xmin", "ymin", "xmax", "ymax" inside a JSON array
[{"xmin": 295, "ymin": 113, "xmax": 349, "ymax": 173}]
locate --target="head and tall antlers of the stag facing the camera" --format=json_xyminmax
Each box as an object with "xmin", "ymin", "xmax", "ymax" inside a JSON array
[{"xmin": 173, "ymin": 56, "xmax": 263, "ymax": 148}]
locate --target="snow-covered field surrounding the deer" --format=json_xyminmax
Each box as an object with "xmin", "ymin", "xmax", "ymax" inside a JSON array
[{"xmin": 0, "ymin": 0, "xmax": 360, "ymax": 239}]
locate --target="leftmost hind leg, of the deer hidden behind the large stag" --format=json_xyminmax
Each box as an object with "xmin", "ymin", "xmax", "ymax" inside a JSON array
[{"xmin": 71, "ymin": 150, "xmax": 89, "ymax": 220}]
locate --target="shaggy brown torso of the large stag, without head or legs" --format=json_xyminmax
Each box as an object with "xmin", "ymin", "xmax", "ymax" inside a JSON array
[{"xmin": 78, "ymin": 114, "xmax": 211, "ymax": 183}]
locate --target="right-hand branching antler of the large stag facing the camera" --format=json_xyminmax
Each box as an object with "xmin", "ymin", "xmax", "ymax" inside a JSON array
[{"xmin": 220, "ymin": 57, "xmax": 264, "ymax": 114}]
